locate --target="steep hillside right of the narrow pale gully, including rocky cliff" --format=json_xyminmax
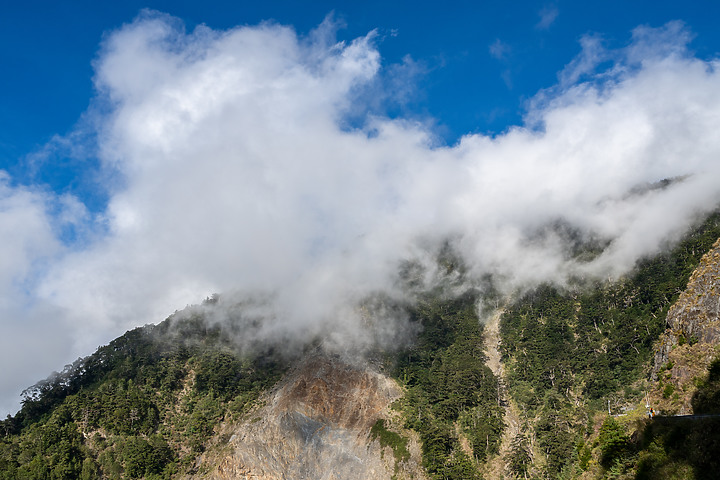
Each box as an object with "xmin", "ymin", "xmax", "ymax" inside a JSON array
[{"xmin": 501, "ymin": 214, "xmax": 720, "ymax": 478}]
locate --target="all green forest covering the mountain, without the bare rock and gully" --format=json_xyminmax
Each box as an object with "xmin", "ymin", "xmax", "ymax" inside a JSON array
[{"xmin": 0, "ymin": 214, "xmax": 720, "ymax": 480}]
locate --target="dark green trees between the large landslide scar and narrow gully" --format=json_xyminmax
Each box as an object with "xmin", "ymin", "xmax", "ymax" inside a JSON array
[{"xmin": 395, "ymin": 291, "xmax": 503, "ymax": 478}]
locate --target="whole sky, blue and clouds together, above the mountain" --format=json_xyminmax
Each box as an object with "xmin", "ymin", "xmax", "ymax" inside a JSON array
[{"xmin": 0, "ymin": 1, "xmax": 720, "ymax": 413}]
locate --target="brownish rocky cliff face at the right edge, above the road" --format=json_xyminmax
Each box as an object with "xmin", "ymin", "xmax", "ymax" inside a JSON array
[{"xmin": 652, "ymin": 240, "xmax": 720, "ymax": 414}]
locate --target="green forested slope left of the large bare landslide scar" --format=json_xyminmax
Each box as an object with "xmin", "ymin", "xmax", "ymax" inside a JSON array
[{"xmin": 0, "ymin": 308, "xmax": 284, "ymax": 480}]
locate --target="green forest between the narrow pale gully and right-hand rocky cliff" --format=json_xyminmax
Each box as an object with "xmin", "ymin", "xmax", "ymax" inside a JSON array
[{"xmin": 501, "ymin": 213, "xmax": 720, "ymax": 478}]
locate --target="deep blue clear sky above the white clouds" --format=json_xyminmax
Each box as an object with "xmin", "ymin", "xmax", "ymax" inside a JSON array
[{"xmin": 5, "ymin": 0, "xmax": 720, "ymax": 207}]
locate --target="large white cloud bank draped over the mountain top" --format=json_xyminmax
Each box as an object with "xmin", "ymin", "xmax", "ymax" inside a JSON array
[{"xmin": 0, "ymin": 12, "xmax": 720, "ymax": 411}]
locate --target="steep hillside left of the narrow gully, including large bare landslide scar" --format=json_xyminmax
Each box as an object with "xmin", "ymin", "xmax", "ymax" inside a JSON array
[{"xmin": 0, "ymin": 280, "xmax": 502, "ymax": 479}]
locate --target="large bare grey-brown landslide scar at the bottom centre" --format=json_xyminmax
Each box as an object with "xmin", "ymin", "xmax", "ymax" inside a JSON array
[{"xmin": 194, "ymin": 356, "xmax": 424, "ymax": 480}]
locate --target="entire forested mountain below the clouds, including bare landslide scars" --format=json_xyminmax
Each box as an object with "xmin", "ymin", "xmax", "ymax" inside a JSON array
[{"xmin": 0, "ymin": 213, "xmax": 720, "ymax": 479}]
